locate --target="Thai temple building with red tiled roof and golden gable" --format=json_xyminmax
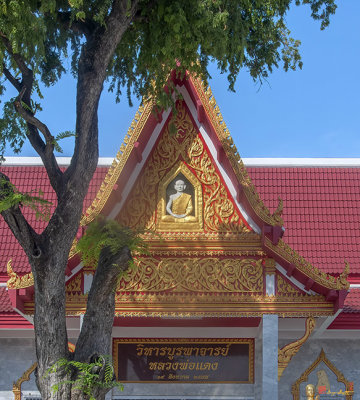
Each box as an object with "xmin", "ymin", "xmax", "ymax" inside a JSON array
[{"xmin": 0, "ymin": 74, "xmax": 360, "ymax": 400}]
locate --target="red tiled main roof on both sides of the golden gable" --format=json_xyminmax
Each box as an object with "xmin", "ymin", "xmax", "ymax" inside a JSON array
[{"xmin": 0, "ymin": 166, "xmax": 360, "ymax": 275}]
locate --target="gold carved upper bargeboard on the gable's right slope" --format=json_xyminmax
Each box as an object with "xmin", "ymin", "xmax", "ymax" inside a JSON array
[{"xmin": 190, "ymin": 76, "xmax": 283, "ymax": 226}]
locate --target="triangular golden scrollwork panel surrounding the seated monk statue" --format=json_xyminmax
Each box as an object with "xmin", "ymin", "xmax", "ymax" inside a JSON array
[{"xmin": 117, "ymin": 101, "xmax": 251, "ymax": 234}]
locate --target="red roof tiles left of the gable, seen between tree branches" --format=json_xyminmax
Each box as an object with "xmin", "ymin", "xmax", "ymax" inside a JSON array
[{"xmin": 0, "ymin": 166, "xmax": 108, "ymax": 276}]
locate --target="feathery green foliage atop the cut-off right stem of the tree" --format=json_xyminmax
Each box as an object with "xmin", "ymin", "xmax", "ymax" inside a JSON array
[{"xmin": 77, "ymin": 218, "xmax": 147, "ymax": 265}]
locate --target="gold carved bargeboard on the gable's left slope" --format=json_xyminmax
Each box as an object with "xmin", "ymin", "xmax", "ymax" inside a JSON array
[{"xmin": 80, "ymin": 100, "xmax": 154, "ymax": 226}]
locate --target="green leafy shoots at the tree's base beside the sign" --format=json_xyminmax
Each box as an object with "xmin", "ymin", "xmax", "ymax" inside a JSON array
[{"xmin": 44, "ymin": 355, "xmax": 123, "ymax": 400}]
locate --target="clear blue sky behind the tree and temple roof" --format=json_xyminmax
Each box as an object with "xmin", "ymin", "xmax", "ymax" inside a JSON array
[{"xmin": 6, "ymin": 0, "xmax": 360, "ymax": 157}]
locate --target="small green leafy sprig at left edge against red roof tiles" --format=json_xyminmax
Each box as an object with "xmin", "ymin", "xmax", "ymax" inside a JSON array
[{"xmin": 0, "ymin": 178, "xmax": 52, "ymax": 221}]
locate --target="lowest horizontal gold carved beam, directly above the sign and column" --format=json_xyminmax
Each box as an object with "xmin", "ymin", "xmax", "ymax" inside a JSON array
[{"xmin": 60, "ymin": 290, "xmax": 333, "ymax": 318}]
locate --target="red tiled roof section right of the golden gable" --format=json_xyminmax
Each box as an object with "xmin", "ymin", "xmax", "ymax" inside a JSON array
[{"xmin": 248, "ymin": 167, "xmax": 360, "ymax": 274}]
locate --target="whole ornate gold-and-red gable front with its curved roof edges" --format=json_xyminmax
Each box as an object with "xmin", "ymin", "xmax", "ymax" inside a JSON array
[{"xmin": 4, "ymin": 71, "xmax": 349, "ymax": 317}]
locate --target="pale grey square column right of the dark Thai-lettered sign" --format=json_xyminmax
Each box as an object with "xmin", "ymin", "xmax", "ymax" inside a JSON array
[{"xmin": 261, "ymin": 314, "xmax": 279, "ymax": 400}]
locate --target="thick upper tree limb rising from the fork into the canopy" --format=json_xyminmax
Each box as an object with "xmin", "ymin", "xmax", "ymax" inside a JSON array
[{"xmin": 65, "ymin": 0, "xmax": 138, "ymax": 187}]
